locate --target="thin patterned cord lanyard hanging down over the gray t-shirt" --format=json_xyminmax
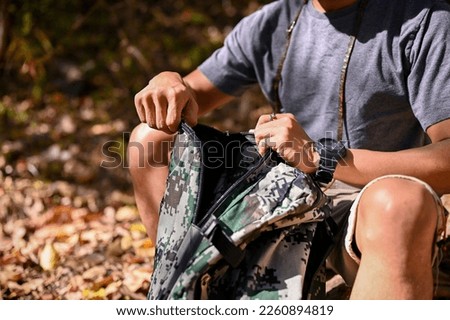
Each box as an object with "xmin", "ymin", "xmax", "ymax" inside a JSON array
[{"xmin": 272, "ymin": 0, "xmax": 368, "ymax": 141}]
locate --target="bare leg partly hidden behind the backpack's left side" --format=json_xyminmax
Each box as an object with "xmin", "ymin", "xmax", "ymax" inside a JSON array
[{"xmin": 128, "ymin": 124, "xmax": 174, "ymax": 241}]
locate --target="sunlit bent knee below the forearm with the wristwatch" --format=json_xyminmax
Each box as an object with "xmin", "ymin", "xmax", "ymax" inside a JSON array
[{"xmin": 356, "ymin": 178, "xmax": 437, "ymax": 254}]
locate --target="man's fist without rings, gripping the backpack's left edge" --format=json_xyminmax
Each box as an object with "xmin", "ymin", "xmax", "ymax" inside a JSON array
[{"xmin": 134, "ymin": 72, "xmax": 198, "ymax": 133}]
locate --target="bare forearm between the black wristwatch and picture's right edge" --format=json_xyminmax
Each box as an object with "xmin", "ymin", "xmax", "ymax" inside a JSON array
[{"xmin": 335, "ymin": 139, "xmax": 450, "ymax": 194}]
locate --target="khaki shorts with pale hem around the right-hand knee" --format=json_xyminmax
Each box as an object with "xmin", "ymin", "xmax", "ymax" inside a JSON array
[{"xmin": 326, "ymin": 175, "xmax": 447, "ymax": 286}]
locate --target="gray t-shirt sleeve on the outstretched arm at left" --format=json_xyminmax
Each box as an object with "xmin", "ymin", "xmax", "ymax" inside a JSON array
[{"xmin": 199, "ymin": 1, "xmax": 286, "ymax": 96}]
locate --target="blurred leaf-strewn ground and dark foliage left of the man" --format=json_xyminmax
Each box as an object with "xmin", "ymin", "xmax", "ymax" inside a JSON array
[{"xmin": 0, "ymin": 0, "xmax": 270, "ymax": 299}]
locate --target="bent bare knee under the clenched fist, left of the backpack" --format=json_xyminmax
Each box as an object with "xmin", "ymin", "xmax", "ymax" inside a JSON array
[{"xmin": 127, "ymin": 124, "xmax": 174, "ymax": 174}]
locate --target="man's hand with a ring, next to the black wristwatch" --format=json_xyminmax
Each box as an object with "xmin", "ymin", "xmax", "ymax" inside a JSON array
[{"xmin": 255, "ymin": 113, "xmax": 319, "ymax": 173}]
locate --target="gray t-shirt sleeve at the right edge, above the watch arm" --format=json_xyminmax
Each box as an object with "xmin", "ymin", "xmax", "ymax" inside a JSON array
[{"xmin": 407, "ymin": 2, "xmax": 450, "ymax": 130}]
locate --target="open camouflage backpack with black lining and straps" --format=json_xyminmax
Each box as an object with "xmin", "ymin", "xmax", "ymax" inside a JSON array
[{"xmin": 148, "ymin": 123, "xmax": 333, "ymax": 299}]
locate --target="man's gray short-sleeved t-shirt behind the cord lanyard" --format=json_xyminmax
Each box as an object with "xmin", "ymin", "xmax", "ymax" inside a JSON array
[{"xmin": 200, "ymin": 0, "xmax": 450, "ymax": 151}]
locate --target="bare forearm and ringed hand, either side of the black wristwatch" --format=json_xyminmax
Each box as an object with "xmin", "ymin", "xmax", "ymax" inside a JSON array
[{"xmin": 255, "ymin": 114, "xmax": 450, "ymax": 194}]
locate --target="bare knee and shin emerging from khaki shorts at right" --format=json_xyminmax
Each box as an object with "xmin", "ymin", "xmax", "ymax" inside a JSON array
[{"xmin": 351, "ymin": 178, "xmax": 437, "ymax": 299}]
